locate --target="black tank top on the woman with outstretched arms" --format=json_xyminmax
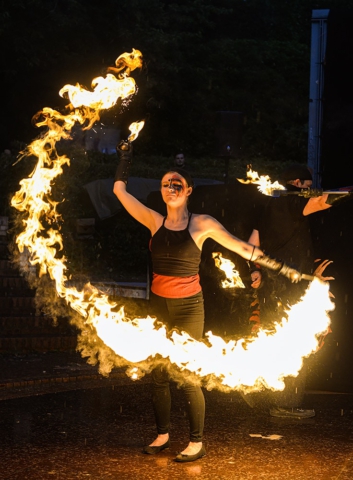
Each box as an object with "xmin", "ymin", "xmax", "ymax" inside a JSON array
[{"xmin": 150, "ymin": 214, "xmax": 201, "ymax": 277}]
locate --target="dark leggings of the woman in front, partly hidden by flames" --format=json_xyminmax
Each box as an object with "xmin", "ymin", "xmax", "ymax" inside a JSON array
[{"xmin": 150, "ymin": 292, "xmax": 205, "ymax": 442}]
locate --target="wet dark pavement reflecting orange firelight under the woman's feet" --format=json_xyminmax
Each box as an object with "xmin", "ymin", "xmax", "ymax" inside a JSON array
[{"xmin": 0, "ymin": 357, "xmax": 353, "ymax": 480}]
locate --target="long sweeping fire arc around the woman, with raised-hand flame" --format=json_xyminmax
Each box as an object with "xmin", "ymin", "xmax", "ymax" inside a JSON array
[{"xmin": 11, "ymin": 50, "xmax": 334, "ymax": 392}]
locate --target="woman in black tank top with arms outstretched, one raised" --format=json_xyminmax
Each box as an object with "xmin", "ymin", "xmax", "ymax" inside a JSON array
[{"xmin": 114, "ymin": 141, "xmax": 301, "ymax": 462}]
